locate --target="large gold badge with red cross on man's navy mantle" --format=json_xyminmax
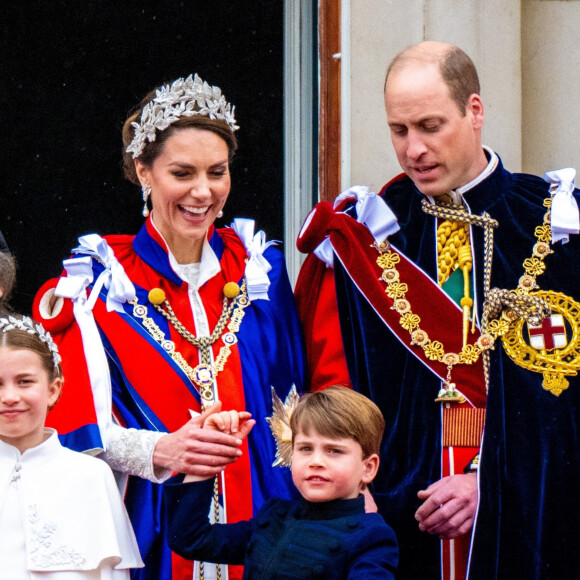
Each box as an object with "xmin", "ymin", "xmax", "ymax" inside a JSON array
[{"xmin": 501, "ymin": 290, "xmax": 580, "ymax": 397}]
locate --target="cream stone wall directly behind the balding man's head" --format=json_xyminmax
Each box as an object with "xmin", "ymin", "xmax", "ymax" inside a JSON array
[{"xmin": 342, "ymin": 0, "xmax": 528, "ymax": 190}]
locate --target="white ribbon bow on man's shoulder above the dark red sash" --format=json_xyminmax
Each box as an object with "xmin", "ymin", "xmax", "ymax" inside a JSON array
[{"xmin": 314, "ymin": 185, "xmax": 401, "ymax": 268}]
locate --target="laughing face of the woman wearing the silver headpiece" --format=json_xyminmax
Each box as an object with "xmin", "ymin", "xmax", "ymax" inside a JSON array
[{"xmin": 136, "ymin": 127, "xmax": 231, "ymax": 263}]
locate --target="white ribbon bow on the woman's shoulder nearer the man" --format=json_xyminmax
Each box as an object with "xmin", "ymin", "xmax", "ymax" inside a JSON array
[{"xmin": 230, "ymin": 218, "xmax": 278, "ymax": 300}]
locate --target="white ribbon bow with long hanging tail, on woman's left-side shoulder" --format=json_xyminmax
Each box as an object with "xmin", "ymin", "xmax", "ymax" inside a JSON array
[{"xmin": 55, "ymin": 234, "xmax": 135, "ymax": 451}]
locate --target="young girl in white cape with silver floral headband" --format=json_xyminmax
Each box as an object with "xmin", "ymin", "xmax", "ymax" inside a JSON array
[{"xmin": 0, "ymin": 316, "xmax": 143, "ymax": 580}]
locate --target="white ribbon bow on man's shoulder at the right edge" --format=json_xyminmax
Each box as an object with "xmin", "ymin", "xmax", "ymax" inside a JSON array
[{"xmin": 544, "ymin": 167, "xmax": 580, "ymax": 244}]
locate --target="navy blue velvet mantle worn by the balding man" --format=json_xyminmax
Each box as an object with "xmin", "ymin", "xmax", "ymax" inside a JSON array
[{"xmin": 335, "ymin": 156, "xmax": 580, "ymax": 580}]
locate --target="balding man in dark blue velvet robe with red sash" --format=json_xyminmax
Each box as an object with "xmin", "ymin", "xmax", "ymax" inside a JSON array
[{"xmin": 297, "ymin": 42, "xmax": 580, "ymax": 580}]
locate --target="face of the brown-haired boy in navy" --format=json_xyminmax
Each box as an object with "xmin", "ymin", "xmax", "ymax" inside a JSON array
[{"xmin": 292, "ymin": 431, "xmax": 379, "ymax": 502}]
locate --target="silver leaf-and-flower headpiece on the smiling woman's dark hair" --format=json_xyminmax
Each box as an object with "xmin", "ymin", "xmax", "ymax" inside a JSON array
[{"xmin": 126, "ymin": 74, "xmax": 239, "ymax": 159}]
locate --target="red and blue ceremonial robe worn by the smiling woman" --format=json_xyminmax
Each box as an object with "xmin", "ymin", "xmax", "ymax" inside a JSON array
[{"xmin": 35, "ymin": 219, "xmax": 305, "ymax": 580}]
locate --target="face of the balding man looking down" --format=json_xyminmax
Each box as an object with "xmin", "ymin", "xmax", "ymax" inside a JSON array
[{"xmin": 385, "ymin": 64, "xmax": 487, "ymax": 196}]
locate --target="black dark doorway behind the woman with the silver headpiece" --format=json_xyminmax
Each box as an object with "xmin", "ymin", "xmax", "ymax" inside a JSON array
[{"xmin": 0, "ymin": 0, "xmax": 284, "ymax": 313}]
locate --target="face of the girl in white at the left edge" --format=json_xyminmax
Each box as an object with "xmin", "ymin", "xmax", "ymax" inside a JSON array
[{"xmin": 0, "ymin": 348, "xmax": 62, "ymax": 453}]
